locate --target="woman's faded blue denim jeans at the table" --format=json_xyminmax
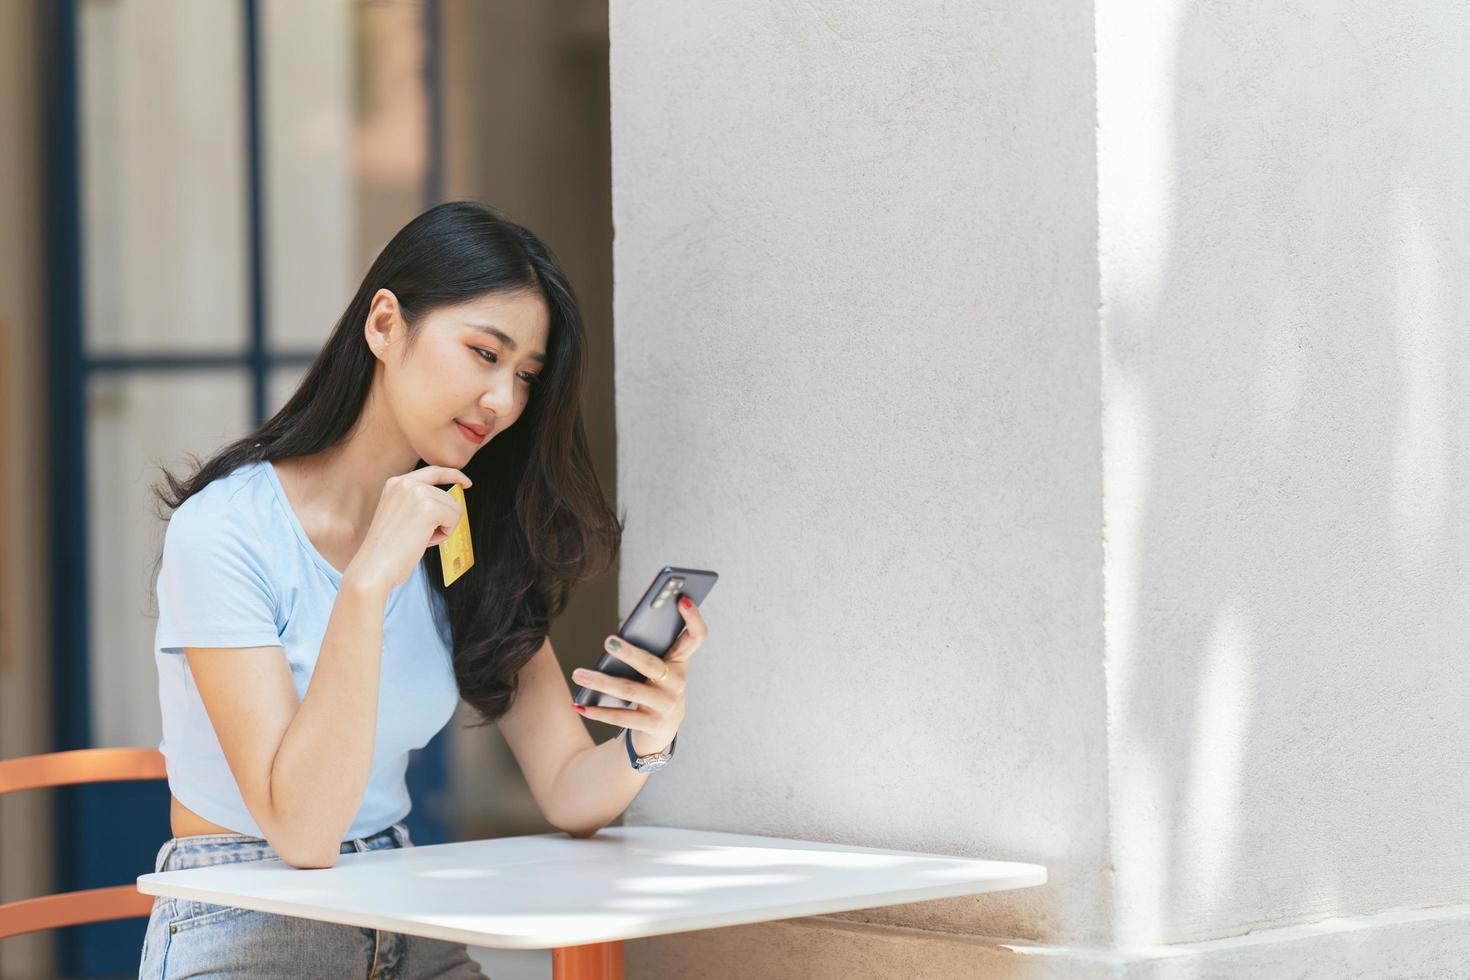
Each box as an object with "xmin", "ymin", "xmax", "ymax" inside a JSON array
[{"xmin": 138, "ymin": 823, "xmax": 488, "ymax": 980}]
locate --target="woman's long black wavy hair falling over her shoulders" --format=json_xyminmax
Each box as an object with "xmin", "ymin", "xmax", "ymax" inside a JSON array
[{"xmin": 153, "ymin": 201, "xmax": 623, "ymax": 727}]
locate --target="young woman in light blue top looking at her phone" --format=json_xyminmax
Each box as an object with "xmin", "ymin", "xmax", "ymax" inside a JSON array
[{"xmin": 138, "ymin": 201, "xmax": 707, "ymax": 977}]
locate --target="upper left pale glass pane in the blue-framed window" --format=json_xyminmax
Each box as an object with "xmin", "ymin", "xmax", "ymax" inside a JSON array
[{"xmin": 76, "ymin": 0, "xmax": 250, "ymax": 356}]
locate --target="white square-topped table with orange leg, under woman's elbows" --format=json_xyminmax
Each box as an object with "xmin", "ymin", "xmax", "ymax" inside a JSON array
[{"xmin": 138, "ymin": 826, "xmax": 1047, "ymax": 980}]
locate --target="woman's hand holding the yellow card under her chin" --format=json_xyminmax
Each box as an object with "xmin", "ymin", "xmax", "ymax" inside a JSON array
[{"xmin": 343, "ymin": 466, "xmax": 470, "ymax": 591}]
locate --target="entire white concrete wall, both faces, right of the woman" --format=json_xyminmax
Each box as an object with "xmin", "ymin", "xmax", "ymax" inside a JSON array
[{"xmin": 612, "ymin": 0, "xmax": 1470, "ymax": 980}]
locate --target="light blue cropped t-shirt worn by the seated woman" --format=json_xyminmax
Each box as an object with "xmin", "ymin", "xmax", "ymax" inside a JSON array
[{"xmin": 153, "ymin": 461, "xmax": 459, "ymax": 839}]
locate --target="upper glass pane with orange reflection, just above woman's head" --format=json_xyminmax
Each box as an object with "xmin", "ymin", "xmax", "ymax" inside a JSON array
[{"xmin": 260, "ymin": 0, "xmax": 428, "ymax": 351}]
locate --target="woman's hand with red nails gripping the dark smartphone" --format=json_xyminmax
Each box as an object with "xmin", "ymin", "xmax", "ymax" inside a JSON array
[{"xmin": 572, "ymin": 595, "xmax": 710, "ymax": 755}]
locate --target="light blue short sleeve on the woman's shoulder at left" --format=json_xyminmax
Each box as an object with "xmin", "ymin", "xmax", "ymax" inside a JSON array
[{"xmin": 154, "ymin": 491, "xmax": 281, "ymax": 654}]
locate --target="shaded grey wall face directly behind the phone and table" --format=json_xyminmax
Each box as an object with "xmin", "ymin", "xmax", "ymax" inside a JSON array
[{"xmin": 612, "ymin": 0, "xmax": 1105, "ymax": 939}]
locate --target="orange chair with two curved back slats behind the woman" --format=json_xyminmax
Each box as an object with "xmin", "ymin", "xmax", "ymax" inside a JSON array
[{"xmin": 0, "ymin": 749, "xmax": 168, "ymax": 939}]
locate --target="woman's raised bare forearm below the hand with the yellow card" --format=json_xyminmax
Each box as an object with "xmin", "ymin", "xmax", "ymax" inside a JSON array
[{"xmin": 270, "ymin": 576, "xmax": 388, "ymax": 867}]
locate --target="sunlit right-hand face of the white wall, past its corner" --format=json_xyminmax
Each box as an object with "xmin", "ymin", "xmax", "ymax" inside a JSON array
[{"xmin": 1097, "ymin": 0, "xmax": 1470, "ymax": 952}]
